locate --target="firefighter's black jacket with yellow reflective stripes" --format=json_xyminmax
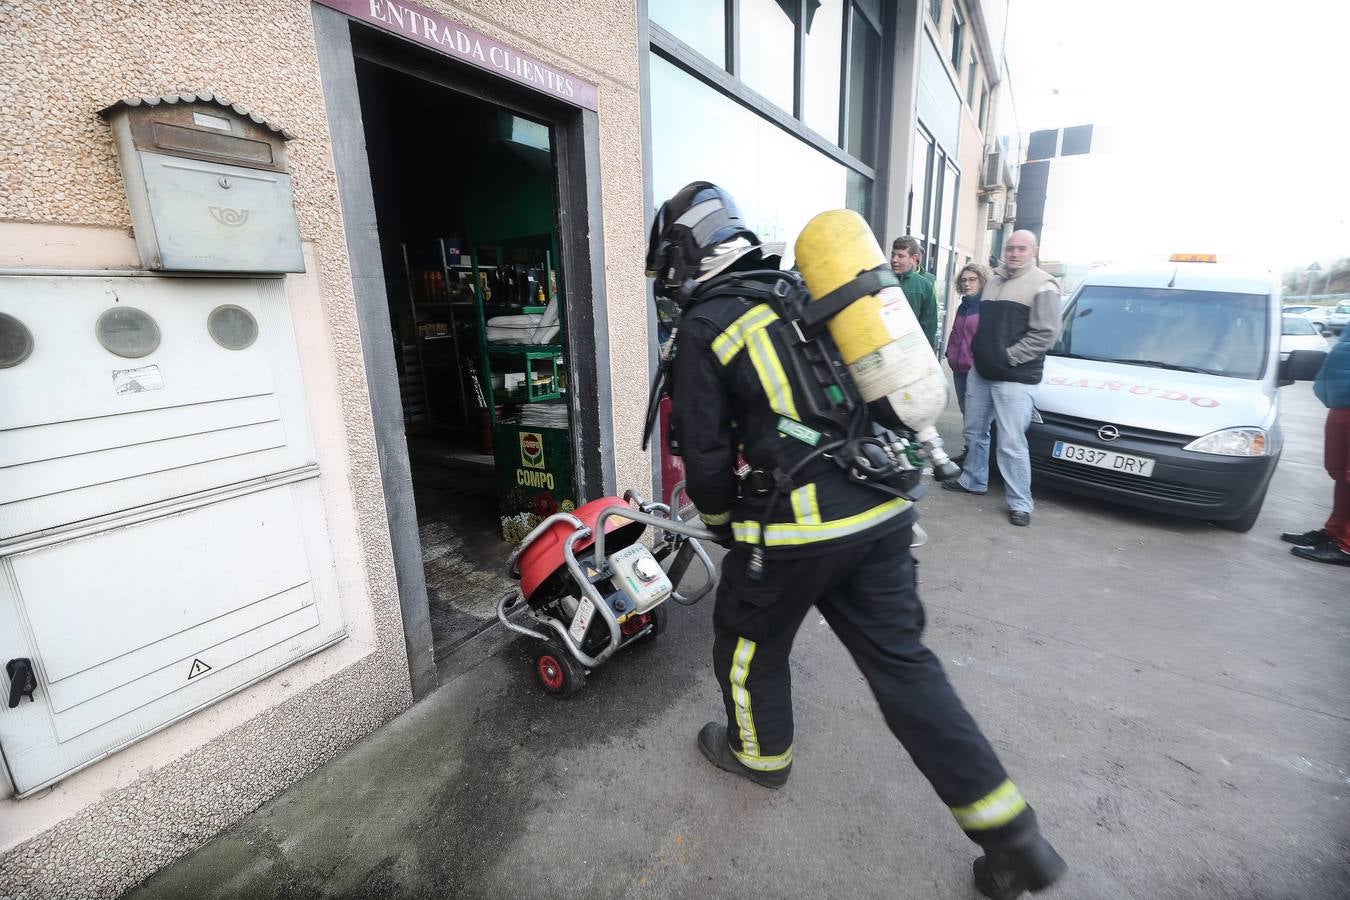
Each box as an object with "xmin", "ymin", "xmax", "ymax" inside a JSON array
[{"xmin": 671, "ymin": 275, "xmax": 914, "ymax": 559}]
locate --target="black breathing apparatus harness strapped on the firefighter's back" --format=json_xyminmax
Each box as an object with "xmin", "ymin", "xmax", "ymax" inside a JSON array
[{"xmin": 643, "ymin": 266, "xmax": 925, "ymax": 580}]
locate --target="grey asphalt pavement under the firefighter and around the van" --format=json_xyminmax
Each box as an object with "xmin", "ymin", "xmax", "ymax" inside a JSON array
[{"xmin": 131, "ymin": 385, "xmax": 1350, "ymax": 900}]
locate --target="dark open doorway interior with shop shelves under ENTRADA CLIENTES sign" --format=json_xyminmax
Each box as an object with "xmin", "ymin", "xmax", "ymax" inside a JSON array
[{"xmin": 356, "ymin": 58, "xmax": 578, "ymax": 663}]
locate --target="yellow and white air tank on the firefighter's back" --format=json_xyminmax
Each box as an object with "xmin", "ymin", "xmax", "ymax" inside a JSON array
[{"xmin": 795, "ymin": 209, "xmax": 959, "ymax": 480}]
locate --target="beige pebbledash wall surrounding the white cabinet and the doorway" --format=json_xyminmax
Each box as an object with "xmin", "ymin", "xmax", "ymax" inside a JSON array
[{"xmin": 0, "ymin": 0, "xmax": 652, "ymax": 897}]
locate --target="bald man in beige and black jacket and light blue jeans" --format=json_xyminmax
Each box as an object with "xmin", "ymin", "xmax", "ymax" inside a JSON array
[{"xmin": 942, "ymin": 231, "xmax": 1060, "ymax": 525}]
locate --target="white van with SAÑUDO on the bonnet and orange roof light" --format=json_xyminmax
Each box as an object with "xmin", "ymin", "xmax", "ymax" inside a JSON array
[{"xmin": 1027, "ymin": 263, "xmax": 1326, "ymax": 532}]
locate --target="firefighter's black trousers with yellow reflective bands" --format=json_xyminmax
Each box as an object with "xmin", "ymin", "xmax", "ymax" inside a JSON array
[{"xmin": 713, "ymin": 528, "xmax": 1035, "ymax": 846}]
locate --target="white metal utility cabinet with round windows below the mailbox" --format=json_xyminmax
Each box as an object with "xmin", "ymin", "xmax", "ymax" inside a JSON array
[{"xmin": 0, "ymin": 275, "xmax": 343, "ymax": 795}]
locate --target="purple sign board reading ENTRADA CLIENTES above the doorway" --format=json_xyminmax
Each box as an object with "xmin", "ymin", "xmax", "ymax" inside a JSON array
[{"xmin": 315, "ymin": 0, "xmax": 599, "ymax": 109}]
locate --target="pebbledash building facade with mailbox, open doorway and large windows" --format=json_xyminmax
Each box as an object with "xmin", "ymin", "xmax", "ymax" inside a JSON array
[{"xmin": 0, "ymin": 0, "xmax": 1015, "ymax": 897}]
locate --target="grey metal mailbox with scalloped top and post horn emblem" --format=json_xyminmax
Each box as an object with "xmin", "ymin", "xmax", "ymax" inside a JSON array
[{"xmin": 100, "ymin": 93, "xmax": 305, "ymax": 274}]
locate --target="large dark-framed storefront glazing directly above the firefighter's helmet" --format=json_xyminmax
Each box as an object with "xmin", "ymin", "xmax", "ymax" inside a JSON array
[{"xmin": 649, "ymin": 0, "xmax": 887, "ymax": 263}]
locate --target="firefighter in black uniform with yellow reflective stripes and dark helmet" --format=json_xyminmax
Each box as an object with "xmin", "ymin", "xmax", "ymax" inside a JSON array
[{"xmin": 647, "ymin": 182, "xmax": 1065, "ymax": 900}]
